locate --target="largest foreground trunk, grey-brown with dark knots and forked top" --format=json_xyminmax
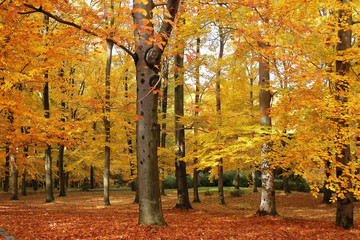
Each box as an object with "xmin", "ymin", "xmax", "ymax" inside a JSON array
[{"xmin": 133, "ymin": 0, "xmax": 180, "ymax": 225}]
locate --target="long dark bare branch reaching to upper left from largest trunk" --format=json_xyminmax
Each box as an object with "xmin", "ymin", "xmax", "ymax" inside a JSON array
[{"xmin": 19, "ymin": 3, "xmax": 136, "ymax": 60}]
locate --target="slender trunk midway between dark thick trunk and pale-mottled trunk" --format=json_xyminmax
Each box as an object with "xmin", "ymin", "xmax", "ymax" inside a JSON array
[{"xmin": 216, "ymin": 27, "xmax": 225, "ymax": 204}]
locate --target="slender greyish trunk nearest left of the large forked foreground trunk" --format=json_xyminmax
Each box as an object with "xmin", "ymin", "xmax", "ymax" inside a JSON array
[{"xmin": 104, "ymin": 40, "xmax": 114, "ymax": 206}]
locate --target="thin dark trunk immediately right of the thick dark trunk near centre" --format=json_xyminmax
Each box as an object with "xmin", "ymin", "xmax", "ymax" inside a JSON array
[{"xmin": 193, "ymin": 38, "xmax": 201, "ymax": 202}]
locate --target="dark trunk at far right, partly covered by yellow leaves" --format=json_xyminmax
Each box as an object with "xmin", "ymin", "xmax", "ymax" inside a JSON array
[{"xmin": 335, "ymin": 0, "xmax": 354, "ymax": 229}]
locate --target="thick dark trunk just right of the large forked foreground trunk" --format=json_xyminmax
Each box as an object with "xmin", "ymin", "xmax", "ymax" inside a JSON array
[{"xmin": 174, "ymin": 47, "xmax": 191, "ymax": 209}]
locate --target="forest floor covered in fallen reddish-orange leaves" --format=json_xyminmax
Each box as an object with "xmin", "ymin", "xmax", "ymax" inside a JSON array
[{"xmin": 0, "ymin": 189, "xmax": 360, "ymax": 240}]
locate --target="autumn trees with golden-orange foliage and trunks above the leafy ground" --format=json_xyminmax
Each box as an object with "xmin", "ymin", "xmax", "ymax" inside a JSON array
[{"xmin": 0, "ymin": 0, "xmax": 360, "ymax": 236}]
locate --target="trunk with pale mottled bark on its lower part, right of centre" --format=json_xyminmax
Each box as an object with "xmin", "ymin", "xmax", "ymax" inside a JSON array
[{"xmin": 257, "ymin": 43, "xmax": 277, "ymax": 215}]
